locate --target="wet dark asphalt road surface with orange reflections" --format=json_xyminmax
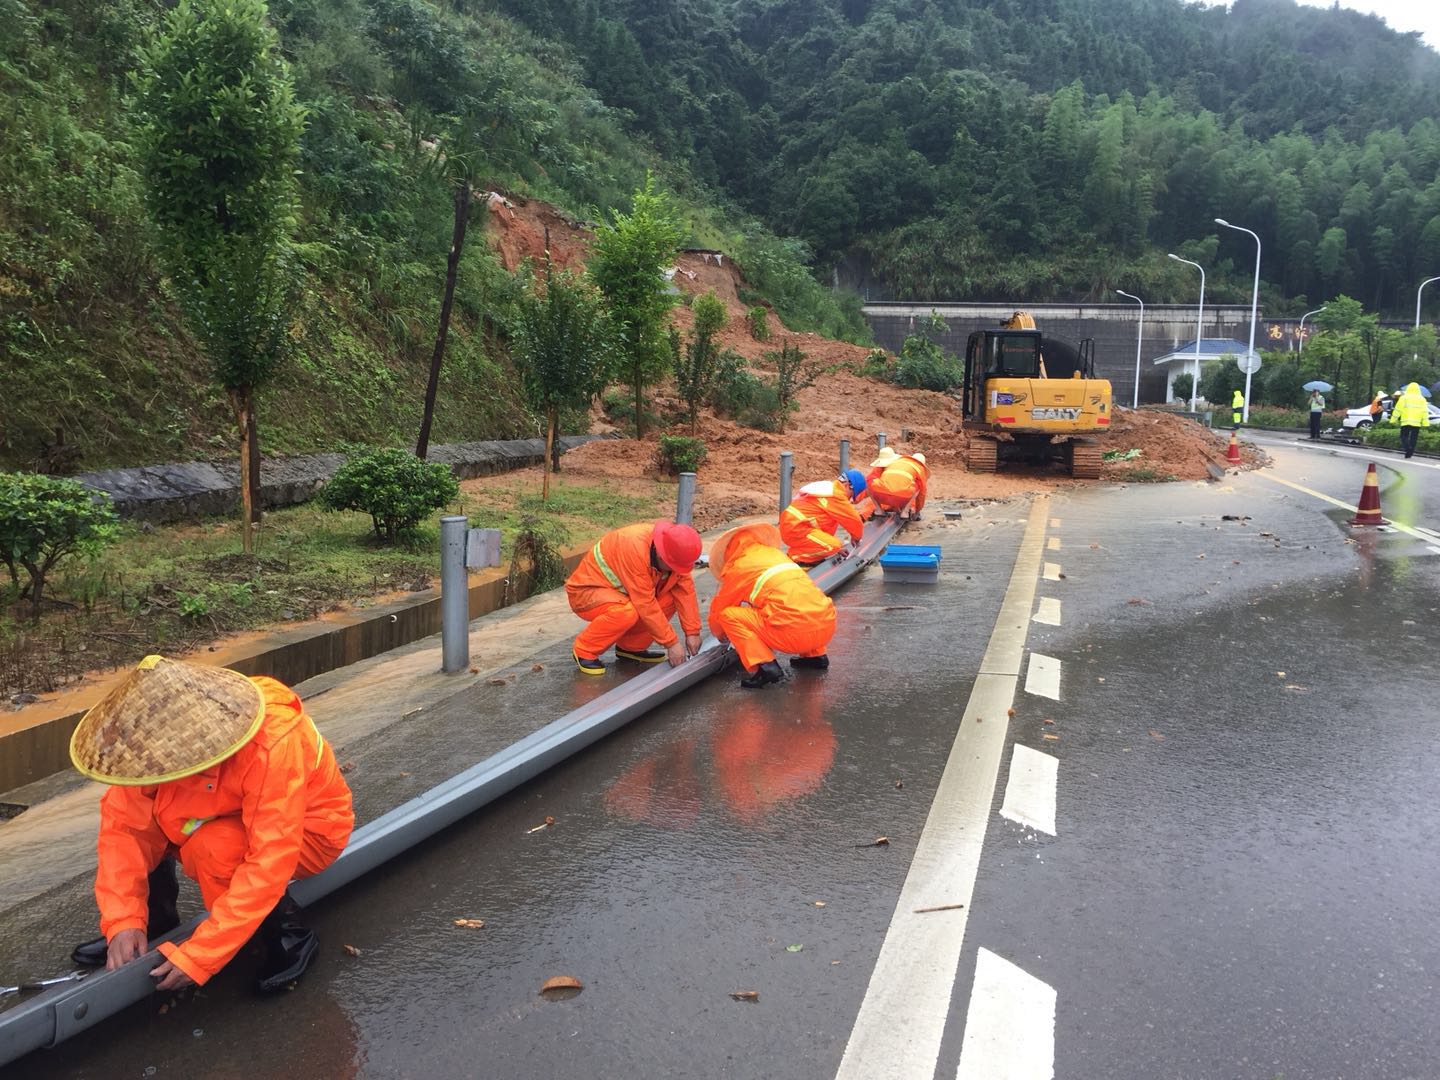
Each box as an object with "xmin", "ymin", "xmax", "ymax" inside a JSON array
[{"xmin": 7, "ymin": 441, "xmax": 1440, "ymax": 1080}]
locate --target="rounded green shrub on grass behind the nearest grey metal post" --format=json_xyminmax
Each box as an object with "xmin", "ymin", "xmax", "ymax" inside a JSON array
[{"xmin": 320, "ymin": 449, "xmax": 459, "ymax": 544}]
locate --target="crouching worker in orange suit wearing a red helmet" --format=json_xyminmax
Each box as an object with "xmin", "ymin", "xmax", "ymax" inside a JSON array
[{"xmin": 564, "ymin": 518, "xmax": 701, "ymax": 675}]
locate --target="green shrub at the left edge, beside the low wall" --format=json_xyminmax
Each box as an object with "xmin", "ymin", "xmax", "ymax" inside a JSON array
[{"xmin": 0, "ymin": 472, "xmax": 115, "ymax": 618}]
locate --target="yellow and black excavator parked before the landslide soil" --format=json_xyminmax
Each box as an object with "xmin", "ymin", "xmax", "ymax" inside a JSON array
[{"xmin": 960, "ymin": 311, "xmax": 1112, "ymax": 480}]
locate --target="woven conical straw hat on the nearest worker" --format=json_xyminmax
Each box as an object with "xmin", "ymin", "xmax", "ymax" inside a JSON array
[{"xmin": 71, "ymin": 657, "xmax": 265, "ymax": 786}]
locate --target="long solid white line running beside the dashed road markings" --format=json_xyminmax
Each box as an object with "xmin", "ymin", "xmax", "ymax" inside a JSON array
[{"xmin": 835, "ymin": 495, "xmax": 1050, "ymax": 1080}]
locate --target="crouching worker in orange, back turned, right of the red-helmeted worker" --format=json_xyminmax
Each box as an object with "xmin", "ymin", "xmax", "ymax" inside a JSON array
[{"xmin": 710, "ymin": 524, "xmax": 835, "ymax": 690}]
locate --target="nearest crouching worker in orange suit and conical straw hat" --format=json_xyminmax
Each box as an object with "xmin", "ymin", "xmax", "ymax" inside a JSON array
[{"xmin": 71, "ymin": 657, "xmax": 354, "ymax": 991}]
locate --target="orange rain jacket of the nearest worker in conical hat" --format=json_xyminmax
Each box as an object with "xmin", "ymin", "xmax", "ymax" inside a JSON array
[{"xmin": 95, "ymin": 677, "xmax": 354, "ymax": 985}]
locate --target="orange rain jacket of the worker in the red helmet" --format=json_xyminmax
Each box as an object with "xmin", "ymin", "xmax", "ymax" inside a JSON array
[{"xmin": 564, "ymin": 521, "xmax": 700, "ymax": 648}]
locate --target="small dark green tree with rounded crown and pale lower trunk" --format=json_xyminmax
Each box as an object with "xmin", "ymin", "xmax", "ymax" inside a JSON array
[{"xmin": 510, "ymin": 261, "xmax": 613, "ymax": 500}]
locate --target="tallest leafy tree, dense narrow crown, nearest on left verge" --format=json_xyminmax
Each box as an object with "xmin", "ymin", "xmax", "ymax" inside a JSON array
[{"xmin": 140, "ymin": 0, "xmax": 305, "ymax": 553}]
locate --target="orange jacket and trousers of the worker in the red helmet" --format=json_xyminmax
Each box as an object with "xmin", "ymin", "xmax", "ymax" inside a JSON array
[{"xmin": 564, "ymin": 521, "xmax": 700, "ymax": 657}]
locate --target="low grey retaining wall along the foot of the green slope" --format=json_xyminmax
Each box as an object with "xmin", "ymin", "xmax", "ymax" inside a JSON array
[{"xmin": 76, "ymin": 435, "xmax": 605, "ymax": 523}]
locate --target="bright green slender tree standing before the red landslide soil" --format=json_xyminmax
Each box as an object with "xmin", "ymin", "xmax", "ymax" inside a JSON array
[{"xmin": 588, "ymin": 176, "xmax": 684, "ymax": 439}]
